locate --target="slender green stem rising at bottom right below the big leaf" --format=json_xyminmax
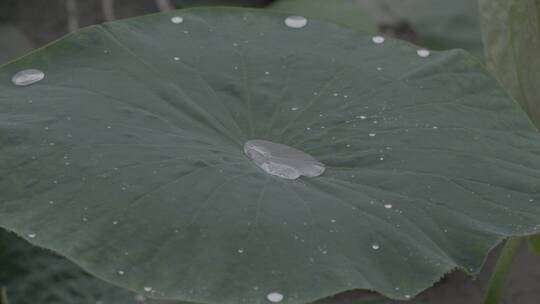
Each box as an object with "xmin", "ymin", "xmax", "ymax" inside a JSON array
[{"xmin": 484, "ymin": 237, "xmax": 523, "ymax": 304}]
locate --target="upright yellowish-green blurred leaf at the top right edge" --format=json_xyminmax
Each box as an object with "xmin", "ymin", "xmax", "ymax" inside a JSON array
[{"xmin": 480, "ymin": 0, "xmax": 540, "ymax": 128}]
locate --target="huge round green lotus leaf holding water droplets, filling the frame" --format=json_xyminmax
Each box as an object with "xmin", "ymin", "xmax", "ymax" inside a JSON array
[{"xmin": 0, "ymin": 9, "xmax": 540, "ymax": 304}]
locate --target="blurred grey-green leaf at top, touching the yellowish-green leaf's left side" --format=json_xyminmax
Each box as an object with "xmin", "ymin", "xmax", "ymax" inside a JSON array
[{"xmin": 388, "ymin": 0, "xmax": 484, "ymax": 58}]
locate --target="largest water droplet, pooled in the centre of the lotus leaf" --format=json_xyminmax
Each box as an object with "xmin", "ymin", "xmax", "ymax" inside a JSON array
[{"xmin": 244, "ymin": 139, "xmax": 325, "ymax": 179}]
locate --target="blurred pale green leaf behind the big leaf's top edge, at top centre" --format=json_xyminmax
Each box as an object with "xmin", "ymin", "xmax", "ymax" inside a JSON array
[{"xmin": 268, "ymin": 0, "xmax": 377, "ymax": 33}]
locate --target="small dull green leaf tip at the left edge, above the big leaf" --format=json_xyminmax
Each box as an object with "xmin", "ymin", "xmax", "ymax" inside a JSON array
[{"xmin": 0, "ymin": 23, "xmax": 32, "ymax": 64}]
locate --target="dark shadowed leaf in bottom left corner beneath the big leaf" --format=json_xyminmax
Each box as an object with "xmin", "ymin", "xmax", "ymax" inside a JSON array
[{"xmin": 0, "ymin": 230, "xmax": 185, "ymax": 304}]
